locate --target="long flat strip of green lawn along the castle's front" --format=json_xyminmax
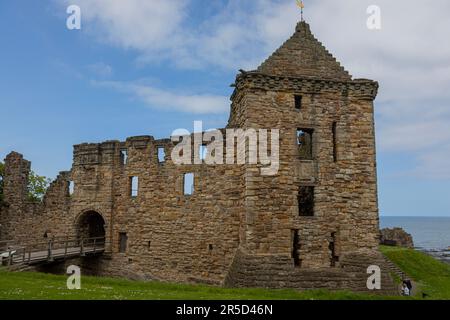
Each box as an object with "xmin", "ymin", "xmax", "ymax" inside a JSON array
[{"xmin": 0, "ymin": 269, "xmax": 384, "ymax": 300}]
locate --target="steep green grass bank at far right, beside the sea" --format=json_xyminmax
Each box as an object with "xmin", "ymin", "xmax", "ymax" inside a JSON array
[{"xmin": 380, "ymin": 246, "xmax": 450, "ymax": 300}]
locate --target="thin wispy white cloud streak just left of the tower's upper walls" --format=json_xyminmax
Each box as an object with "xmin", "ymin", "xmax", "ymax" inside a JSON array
[{"xmin": 92, "ymin": 81, "xmax": 229, "ymax": 114}]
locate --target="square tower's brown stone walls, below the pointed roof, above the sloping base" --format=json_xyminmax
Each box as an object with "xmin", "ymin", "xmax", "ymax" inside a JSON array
[{"xmin": 229, "ymin": 73, "xmax": 378, "ymax": 267}]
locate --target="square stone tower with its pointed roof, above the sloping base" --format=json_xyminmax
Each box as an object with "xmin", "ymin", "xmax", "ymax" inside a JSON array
[{"xmin": 229, "ymin": 22, "xmax": 379, "ymax": 268}]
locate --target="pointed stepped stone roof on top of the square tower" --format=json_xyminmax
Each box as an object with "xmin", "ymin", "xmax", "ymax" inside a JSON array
[{"xmin": 257, "ymin": 21, "xmax": 352, "ymax": 81}]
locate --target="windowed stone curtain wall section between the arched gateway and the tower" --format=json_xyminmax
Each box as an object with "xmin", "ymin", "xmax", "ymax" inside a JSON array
[{"xmin": 75, "ymin": 137, "xmax": 242, "ymax": 281}]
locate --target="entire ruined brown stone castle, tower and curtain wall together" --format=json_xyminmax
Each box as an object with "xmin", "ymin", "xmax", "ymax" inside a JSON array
[{"xmin": 0, "ymin": 22, "xmax": 392, "ymax": 292}]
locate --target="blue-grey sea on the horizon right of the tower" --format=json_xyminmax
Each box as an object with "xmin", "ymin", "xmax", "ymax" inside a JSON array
[{"xmin": 380, "ymin": 216, "xmax": 450, "ymax": 263}]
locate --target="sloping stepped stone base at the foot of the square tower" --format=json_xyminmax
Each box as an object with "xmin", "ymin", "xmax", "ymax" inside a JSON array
[{"xmin": 224, "ymin": 250, "xmax": 399, "ymax": 295}]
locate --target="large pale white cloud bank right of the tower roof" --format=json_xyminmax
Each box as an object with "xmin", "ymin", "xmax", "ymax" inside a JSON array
[{"xmin": 296, "ymin": 0, "xmax": 450, "ymax": 179}]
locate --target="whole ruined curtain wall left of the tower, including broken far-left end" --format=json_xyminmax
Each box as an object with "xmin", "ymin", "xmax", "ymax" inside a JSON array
[{"xmin": 1, "ymin": 144, "xmax": 242, "ymax": 283}]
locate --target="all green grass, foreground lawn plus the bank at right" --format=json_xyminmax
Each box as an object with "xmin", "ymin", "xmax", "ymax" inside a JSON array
[{"xmin": 0, "ymin": 247, "xmax": 450, "ymax": 300}]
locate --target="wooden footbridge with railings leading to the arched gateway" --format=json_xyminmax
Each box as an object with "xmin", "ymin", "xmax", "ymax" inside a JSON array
[{"xmin": 0, "ymin": 237, "xmax": 105, "ymax": 266}]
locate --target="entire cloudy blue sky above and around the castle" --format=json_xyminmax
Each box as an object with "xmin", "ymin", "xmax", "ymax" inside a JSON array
[{"xmin": 0, "ymin": 0, "xmax": 450, "ymax": 216}]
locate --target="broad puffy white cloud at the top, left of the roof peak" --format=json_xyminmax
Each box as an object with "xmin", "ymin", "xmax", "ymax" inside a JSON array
[{"xmin": 54, "ymin": 0, "xmax": 298, "ymax": 69}]
